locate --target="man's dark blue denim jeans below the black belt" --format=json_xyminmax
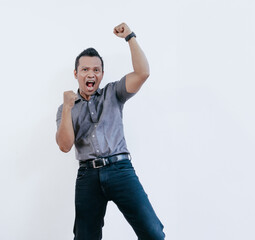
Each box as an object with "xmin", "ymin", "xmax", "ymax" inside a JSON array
[{"xmin": 74, "ymin": 160, "xmax": 165, "ymax": 240}]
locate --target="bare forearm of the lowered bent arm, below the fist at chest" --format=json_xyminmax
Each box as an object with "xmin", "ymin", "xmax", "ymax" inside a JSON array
[{"xmin": 56, "ymin": 106, "xmax": 74, "ymax": 152}]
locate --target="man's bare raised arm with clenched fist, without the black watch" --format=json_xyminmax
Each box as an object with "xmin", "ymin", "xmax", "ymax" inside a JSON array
[{"xmin": 113, "ymin": 23, "xmax": 150, "ymax": 93}]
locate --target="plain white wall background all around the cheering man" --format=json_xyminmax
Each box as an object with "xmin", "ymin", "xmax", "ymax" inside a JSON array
[{"xmin": 0, "ymin": 0, "xmax": 255, "ymax": 240}]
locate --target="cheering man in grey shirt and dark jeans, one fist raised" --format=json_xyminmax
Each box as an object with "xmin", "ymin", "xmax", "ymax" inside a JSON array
[{"xmin": 56, "ymin": 23, "xmax": 165, "ymax": 240}]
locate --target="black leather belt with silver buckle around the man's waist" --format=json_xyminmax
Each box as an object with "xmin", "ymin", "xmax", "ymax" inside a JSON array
[{"xmin": 80, "ymin": 154, "xmax": 131, "ymax": 168}]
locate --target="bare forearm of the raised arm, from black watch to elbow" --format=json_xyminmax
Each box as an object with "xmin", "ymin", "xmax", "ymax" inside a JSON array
[{"xmin": 128, "ymin": 37, "xmax": 150, "ymax": 77}]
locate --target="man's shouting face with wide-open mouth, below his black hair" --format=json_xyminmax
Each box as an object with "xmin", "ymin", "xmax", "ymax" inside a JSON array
[{"xmin": 74, "ymin": 56, "xmax": 104, "ymax": 100}]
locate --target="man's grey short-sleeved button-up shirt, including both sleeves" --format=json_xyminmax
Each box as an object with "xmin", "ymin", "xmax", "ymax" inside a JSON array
[{"xmin": 57, "ymin": 76, "xmax": 134, "ymax": 160}]
